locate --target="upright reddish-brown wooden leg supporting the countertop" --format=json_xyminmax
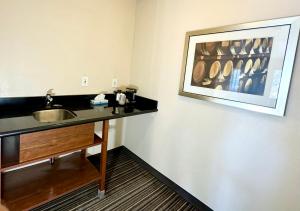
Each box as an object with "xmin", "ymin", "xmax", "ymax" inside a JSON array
[{"xmin": 99, "ymin": 120, "xmax": 109, "ymax": 198}]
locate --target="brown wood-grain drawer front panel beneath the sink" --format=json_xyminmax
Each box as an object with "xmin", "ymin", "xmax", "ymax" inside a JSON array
[{"xmin": 20, "ymin": 123, "xmax": 94, "ymax": 163}]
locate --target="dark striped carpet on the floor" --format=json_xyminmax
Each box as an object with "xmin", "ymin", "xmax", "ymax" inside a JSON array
[{"xmin": 34, "ymin": 150, "xmax": 200, "ymax": 211}]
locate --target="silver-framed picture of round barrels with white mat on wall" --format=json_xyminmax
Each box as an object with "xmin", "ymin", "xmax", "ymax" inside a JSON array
[{"xmin": 179, "ymin": 16, "xmax": 300, "ymax": 116}]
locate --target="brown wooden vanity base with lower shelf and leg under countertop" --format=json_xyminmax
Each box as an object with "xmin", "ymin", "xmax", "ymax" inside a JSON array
[{"xmin": 0, "ymin": 120, "xmax": 109, "ymax": 210}]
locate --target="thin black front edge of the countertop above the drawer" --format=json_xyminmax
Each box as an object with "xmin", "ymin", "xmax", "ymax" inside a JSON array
[{"xmin": 0, "ymin": 109, "xmax": 158, "ymax": 138}]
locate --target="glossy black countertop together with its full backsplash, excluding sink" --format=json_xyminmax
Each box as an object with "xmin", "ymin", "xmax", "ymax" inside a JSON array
[{"xmin": 0, "ymin": 94, "xmax": 158, "ymax": 138}]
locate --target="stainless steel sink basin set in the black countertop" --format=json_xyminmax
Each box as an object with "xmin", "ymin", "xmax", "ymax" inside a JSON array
[{"xmin": 32, "ymin": 109, "xmax": 76, "ymax": 122}]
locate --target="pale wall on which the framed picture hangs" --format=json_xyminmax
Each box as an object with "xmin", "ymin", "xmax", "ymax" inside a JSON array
[{"xmin": 125, "ymin": 0, "xmax": 300, "ymax": 211}]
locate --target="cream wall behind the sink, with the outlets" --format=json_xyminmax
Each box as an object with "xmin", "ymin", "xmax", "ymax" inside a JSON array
[{"xmin": 0, "ymin": 0, "xmax": 135, "ymax": 97}]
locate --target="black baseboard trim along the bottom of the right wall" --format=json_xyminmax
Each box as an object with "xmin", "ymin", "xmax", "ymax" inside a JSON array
[{"xmin": 119, "ymin": 146, "xmax": 212, "ymax": 211}]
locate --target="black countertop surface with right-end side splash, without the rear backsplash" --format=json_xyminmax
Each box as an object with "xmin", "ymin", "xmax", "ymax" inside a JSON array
[{"xmin": 0, "ymin": 96, "xmax": 157, "ymax": 137}]
